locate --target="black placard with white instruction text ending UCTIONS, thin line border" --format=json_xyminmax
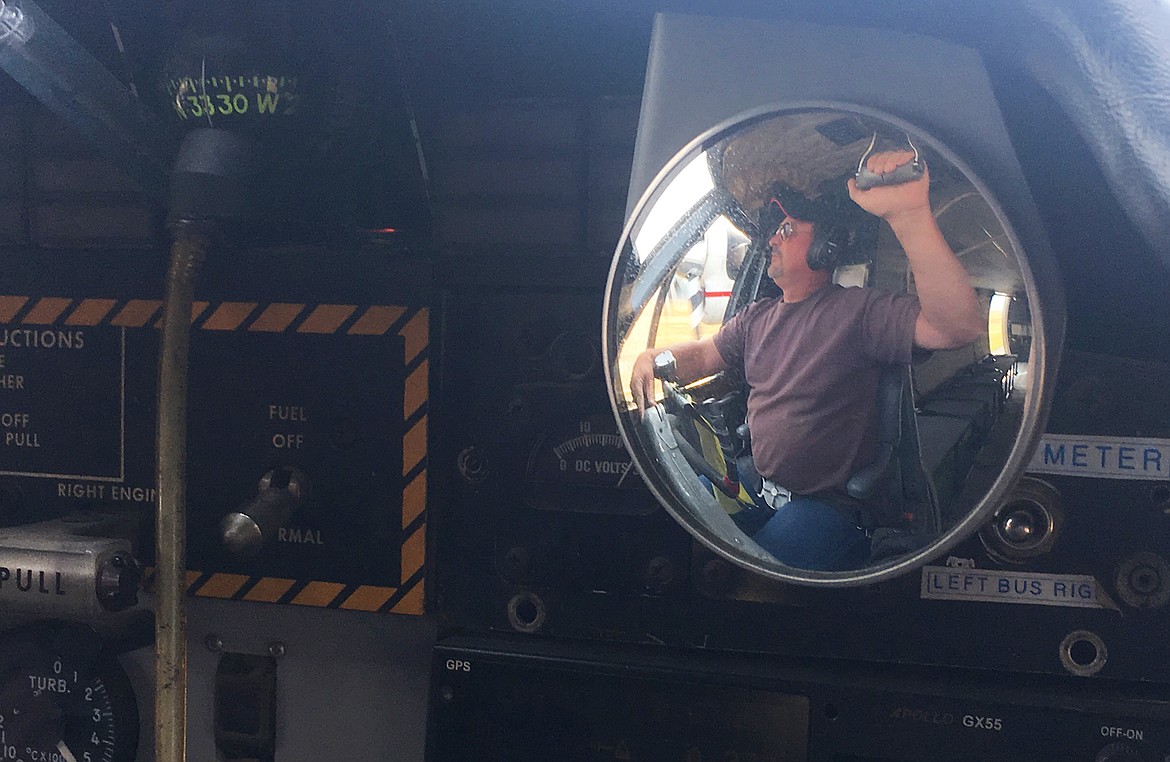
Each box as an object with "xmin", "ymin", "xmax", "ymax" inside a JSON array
[{"xmin": 0, "ymin": 328, "xmax": 125, "ymax": 481}]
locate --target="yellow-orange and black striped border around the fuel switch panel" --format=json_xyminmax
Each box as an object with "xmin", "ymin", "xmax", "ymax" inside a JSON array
[{"xmin": 0, "ymin": 296, "xmax": 431, "ymax": 615}]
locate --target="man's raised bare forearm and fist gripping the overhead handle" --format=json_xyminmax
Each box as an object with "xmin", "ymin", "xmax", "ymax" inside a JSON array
[{"xmin": 848, "ymin": 151, "xmax": 987, "ymax": 349}]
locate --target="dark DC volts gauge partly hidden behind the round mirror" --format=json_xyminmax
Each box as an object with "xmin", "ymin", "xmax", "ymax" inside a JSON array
[{"xmin": 527, "ymin": 414, "xmax": 655, "ymax": 514}]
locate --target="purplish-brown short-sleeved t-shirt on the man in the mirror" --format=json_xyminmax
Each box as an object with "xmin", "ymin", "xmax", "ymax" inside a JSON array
[{"xmin": 715, "ymin": 284, "xmax": 918, "ymax": 494}]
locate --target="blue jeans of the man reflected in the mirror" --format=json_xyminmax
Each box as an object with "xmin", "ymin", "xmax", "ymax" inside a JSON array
[{"xmin": 752, "ymin": 497, "xmax": 869, "ymax": 571}]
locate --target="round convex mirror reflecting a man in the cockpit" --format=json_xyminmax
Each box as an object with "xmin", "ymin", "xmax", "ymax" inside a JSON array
[{"xmin": 604, "ymin": 104, "xmax": 1045, "ymax": 585}]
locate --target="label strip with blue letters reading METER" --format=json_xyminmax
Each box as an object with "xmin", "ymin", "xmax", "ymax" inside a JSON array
[{"xmin": 1027, "ymin": 434, "xmax": 1170, "ymax": 480}]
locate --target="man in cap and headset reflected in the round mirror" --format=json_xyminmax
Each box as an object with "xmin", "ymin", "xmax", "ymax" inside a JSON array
[{"xmin": 629, "ymin": 151, "xmax": 986, "ymax": 571}]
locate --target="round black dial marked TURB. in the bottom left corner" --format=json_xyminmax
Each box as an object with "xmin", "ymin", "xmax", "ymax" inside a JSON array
[{"xmin": 0, "ymin": 625, "xmax": 138, "ymax": 762}]
